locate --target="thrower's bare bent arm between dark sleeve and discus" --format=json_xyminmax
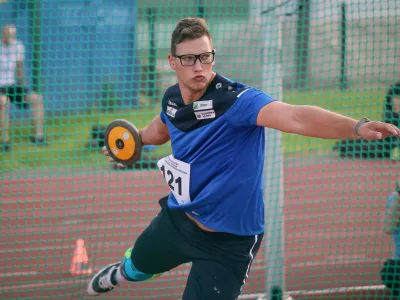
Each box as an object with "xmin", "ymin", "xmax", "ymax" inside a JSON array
[{"xmin": 139, "ymin": 116, "xmax": 169, "ymax": 145}]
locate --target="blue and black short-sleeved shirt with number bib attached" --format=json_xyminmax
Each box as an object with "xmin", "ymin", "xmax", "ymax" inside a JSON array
[{"xmin": 159, "ymin": 74, "xmax": 273, "ymax": 235}]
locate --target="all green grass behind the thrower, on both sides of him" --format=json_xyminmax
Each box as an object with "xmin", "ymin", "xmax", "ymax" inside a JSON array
[{"xmin": 0, "ymin": 91, "xmax": 384, "ymax": 172}]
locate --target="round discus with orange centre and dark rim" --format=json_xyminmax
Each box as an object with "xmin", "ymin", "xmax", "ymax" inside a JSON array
[{"xmin": 104, "ymin": 119, "xmax": 142, "ymax": 166}]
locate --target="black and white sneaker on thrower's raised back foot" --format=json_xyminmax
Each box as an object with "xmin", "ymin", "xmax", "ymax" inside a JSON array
[{"xmin": 87, "ymin": 262, "xmax": 121, "ymax": 296}]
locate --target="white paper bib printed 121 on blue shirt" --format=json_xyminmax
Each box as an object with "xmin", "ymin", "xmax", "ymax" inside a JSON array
[{"xmin": 157, "ymin": 155, "xmax": 190, "ymax": 204}]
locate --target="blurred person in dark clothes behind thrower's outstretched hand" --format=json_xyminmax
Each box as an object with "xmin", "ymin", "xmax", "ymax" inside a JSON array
[{"xmin": 333, "ymin": 81, "xmax": 400, "ymax": 160}]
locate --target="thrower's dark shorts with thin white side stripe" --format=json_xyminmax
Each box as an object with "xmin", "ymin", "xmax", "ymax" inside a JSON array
[{"xmin": 131, "ymin": 197, "xmax": 263, "ymax": 300}]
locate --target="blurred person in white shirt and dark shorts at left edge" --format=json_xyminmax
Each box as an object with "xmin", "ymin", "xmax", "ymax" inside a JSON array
[{"xmin": 0, "ymin": 24, "xmax": 45, "ymax": 152}]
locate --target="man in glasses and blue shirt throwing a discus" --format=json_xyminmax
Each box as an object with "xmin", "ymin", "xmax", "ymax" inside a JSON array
[{"xmin": 87, "ymin": 18, "xmax": 400, "ymax": 300}]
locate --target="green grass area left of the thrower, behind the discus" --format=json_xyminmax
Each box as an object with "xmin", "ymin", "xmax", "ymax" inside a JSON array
[{"xmin": 0, "ymin": 107, "xmax": 170, "ymax": 171}]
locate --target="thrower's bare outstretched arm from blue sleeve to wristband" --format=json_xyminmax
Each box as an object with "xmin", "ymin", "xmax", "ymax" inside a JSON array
[{"xmin": 257, "ymin": 101, "xmax": 358, "ymax": 139}]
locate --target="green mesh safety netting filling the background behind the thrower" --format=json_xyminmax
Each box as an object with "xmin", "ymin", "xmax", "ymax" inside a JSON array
[{"xmin": 0, "ymin": 0, "xmax": 400, "ymax": 300}]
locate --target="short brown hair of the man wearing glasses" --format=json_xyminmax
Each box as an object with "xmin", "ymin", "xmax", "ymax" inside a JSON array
[{"xmin": 171, "ymin": 18, "xmax": 212, "ymax": 55}]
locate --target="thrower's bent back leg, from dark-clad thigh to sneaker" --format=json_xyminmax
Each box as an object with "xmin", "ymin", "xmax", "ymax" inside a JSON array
[{"xmin": 88, "ymin": 198, "xmax": 190, "ymax": 296}]
